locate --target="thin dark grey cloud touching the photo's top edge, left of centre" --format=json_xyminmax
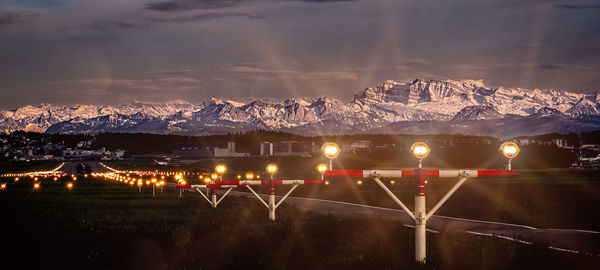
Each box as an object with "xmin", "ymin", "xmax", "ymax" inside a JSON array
[{"xmin": 146, "ymin": 0, "xmax": 245, "ymax": 12}]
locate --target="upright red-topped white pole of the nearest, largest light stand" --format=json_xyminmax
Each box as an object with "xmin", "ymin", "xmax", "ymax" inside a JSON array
[{"xmin": 415, "ymin": 168, "xmax": 427, "ymax": 263}]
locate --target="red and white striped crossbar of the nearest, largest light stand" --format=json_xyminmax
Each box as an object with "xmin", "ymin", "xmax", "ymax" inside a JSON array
[{"xmin": 325, "ymin": 170, "xmax": 517, "ymax": 178}]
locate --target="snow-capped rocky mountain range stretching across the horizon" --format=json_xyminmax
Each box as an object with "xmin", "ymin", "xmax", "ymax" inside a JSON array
[{"xmin": 0, "ymin": 79, "xmax": 600, "ymax": 137}]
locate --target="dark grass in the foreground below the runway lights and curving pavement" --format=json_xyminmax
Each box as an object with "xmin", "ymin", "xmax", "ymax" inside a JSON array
[{"xmin": 0, "ymin": 178, "xmax": 600, "ymax": 269}]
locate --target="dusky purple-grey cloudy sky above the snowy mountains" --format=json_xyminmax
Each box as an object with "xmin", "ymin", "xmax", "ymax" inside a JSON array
[{"xmin": 0, "ymin": 0, "xmax": 600, "ymax": 109}]
